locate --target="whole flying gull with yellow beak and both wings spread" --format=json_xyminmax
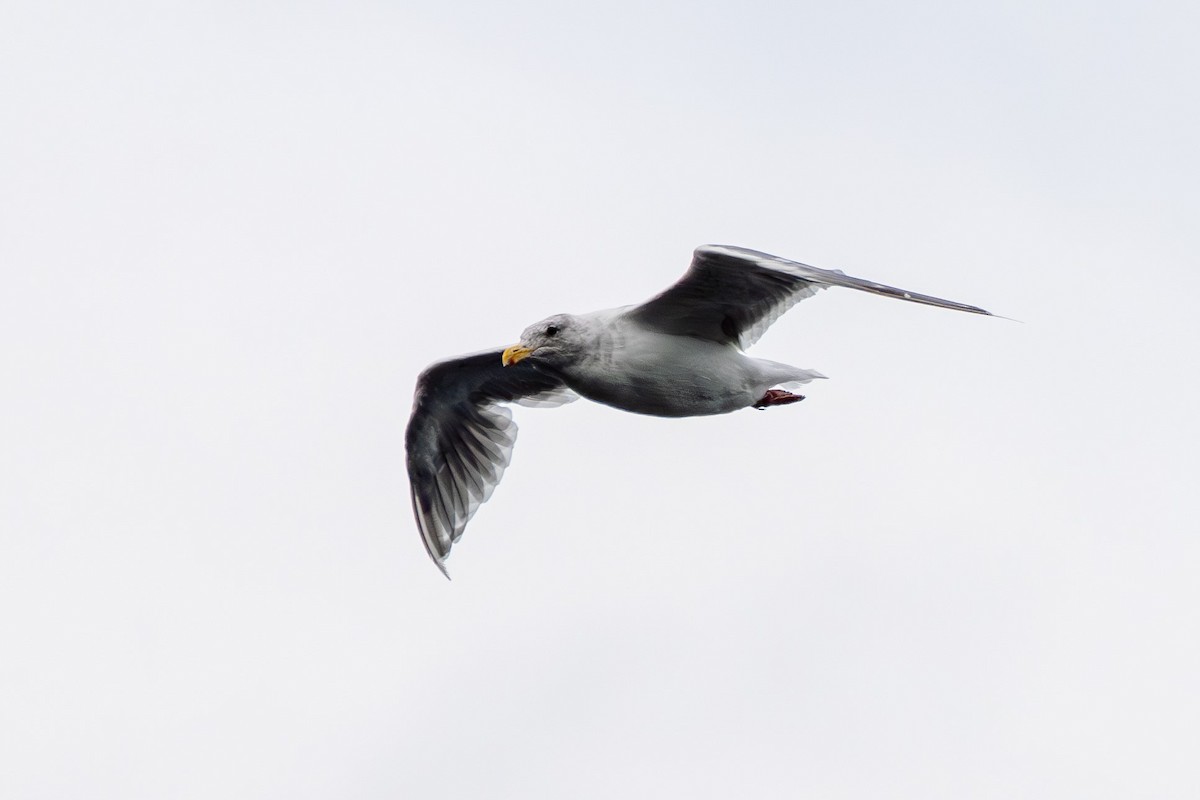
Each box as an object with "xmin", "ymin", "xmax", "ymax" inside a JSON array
[{"xmin": 404, "ymin": 245, "xmax": 990, "ymax": 578}]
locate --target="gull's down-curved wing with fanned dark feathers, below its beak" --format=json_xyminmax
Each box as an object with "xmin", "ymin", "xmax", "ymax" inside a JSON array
[{"xmin": 404, "ymin": 350, "xmax": 577, "ymax": 577}]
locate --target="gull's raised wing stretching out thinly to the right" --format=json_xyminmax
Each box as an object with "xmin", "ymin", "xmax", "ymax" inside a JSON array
[{"xmin": 626, "ymin": 245, "xmax": 989, "ymax": 349}]
